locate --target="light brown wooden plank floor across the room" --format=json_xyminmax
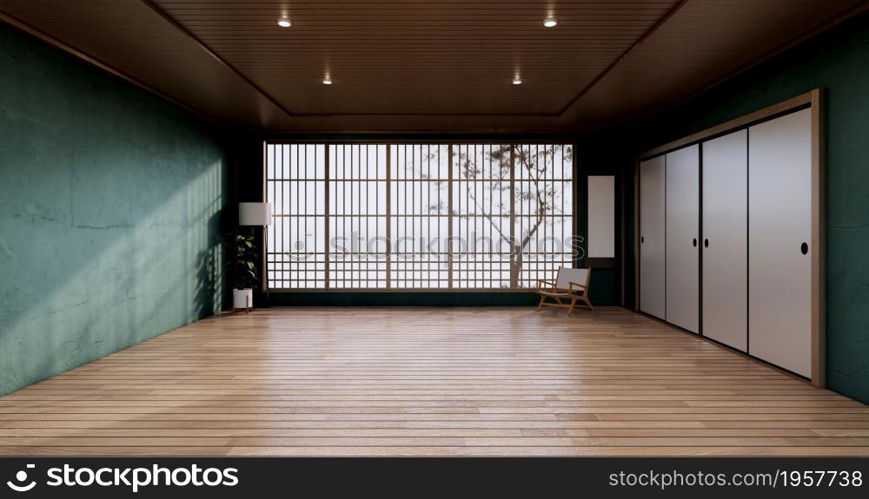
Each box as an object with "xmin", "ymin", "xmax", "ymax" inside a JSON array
[{"xmin": 0, "ymin": 308, "xmax": 869, "ymax": 456}]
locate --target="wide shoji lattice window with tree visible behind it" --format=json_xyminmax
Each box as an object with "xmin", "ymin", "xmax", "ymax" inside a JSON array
[{"xmin": 265, "ymin": 143, "xmax": 579, "ymax": 291}]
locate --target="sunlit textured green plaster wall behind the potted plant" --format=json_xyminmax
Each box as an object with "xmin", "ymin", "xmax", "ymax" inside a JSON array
[{"xmin": 0, "ymin": 25, "xmax": 226, "ymax": 394}]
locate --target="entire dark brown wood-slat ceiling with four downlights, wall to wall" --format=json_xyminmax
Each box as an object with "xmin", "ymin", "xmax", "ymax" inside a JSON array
[{"xmin": 0, "ymin": 0, "xmax": 867, "ymax": 132}]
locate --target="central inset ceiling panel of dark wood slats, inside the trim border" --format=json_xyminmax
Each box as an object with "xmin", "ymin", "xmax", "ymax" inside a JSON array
[{"xmin": 156, "ymin": 0, "xmax": 678, "ymax": 115}]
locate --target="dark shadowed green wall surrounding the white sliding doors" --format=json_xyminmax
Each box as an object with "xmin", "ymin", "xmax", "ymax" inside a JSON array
[{"xmin": 608, "ymin": 14, "xmax": 869, "ymax": 403}]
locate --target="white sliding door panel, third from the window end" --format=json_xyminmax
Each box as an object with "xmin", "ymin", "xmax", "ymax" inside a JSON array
[{"xmin": 701, "ymin": 130, "xmax": 748, "ymax": 352}]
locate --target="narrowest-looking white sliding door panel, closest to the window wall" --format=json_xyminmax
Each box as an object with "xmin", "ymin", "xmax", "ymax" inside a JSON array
[{"xmin": 640, "ymin": 156, "xmax": 667, "ymax": 319}]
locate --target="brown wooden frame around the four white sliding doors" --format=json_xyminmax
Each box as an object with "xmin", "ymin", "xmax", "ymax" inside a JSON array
[{"xmin": 634, "ymin": 88, "xmax": 826, "ymax": 388}]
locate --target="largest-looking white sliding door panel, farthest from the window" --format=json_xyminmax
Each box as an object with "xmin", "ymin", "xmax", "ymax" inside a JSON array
[{"xmin": 748, "ymin": 109, "xmax": 817, "ymax": 377}]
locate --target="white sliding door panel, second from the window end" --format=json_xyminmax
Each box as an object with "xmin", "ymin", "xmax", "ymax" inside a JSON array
[{"xmin": 666, "ymin": 145, "xmax": 700, "ymax": 333}]
